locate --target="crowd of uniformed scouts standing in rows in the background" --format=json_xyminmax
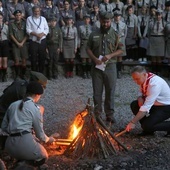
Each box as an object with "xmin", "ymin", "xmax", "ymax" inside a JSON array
[{"xmin": 0, "ymin": 0, "xmax": 170, "ymax": 81}]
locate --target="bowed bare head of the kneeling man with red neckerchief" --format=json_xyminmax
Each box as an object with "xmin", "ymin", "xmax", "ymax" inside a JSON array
[{"xmin": 131, "ymin": 66, "xmax": 147, "ymax": 86}]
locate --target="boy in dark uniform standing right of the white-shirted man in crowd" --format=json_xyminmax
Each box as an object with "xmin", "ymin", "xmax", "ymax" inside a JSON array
[{"xmin": 47, "ymin": 17, "xmax": 62, "ymax": 80}]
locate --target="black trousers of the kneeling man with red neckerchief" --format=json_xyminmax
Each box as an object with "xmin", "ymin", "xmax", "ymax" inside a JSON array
[{"xmin": 130, "ymin": 100, "xmax": 170, "ymax": 132}]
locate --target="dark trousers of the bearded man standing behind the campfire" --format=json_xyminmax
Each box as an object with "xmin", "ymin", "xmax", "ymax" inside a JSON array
[{"xmin": 91, "ymin": 63, "xmax": 117, "ymax": 118}]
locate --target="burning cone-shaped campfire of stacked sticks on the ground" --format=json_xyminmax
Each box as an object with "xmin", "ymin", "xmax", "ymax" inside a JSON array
[{"xmin": 56, "ymin": 99, "xmax": 128, "ymax": 159}]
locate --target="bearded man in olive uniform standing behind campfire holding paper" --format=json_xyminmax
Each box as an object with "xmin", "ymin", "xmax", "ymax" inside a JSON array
[{"xmin": 87, "ymin": 13, "xmax": 123, "ymax": 123}]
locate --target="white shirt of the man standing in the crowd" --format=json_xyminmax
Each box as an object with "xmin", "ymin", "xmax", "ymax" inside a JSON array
[{"xmin": 26, "ymin": 16, "xmax": 49, "ymax": 43}]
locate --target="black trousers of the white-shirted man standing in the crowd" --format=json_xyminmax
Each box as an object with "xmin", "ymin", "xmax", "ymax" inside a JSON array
[{"xmin": 30, "ymin": 39, "xmax": 46, "ymax": 73}]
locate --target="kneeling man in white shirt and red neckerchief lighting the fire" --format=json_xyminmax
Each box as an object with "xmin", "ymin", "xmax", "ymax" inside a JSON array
[{"xmin": 126, "ymin": 66, "xmax": 170, "ymax": 135}]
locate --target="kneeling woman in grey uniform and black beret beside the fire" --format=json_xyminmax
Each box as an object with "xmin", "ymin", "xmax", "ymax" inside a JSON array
[{"xmin": 1, "ymin": 82, "xmax": 55, "ymax": 166}]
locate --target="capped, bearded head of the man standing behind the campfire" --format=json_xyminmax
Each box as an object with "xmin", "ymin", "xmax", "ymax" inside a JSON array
[{"xmin": 100, "ymin": 13, "xmax": 113, "ymax": 33}]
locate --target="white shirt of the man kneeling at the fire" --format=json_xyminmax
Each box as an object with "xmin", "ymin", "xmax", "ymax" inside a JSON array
[{"xmin": 139, "ymin": 75, "xmax": 170, "ymax": 113}]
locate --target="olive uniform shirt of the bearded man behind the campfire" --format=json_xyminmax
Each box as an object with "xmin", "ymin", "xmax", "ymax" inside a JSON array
[{"xmin": 87, "ymin": 28, "xmax": 123, "ymax": 63}]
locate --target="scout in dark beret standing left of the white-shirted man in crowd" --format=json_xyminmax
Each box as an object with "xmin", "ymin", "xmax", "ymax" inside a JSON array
[{"xmin": 9, "ymin": 10, "xmax": 28, "ymax": 78}]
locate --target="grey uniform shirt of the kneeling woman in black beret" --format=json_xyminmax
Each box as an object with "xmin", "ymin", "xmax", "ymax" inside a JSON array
[{"xmin": 1, "ymin": 97, "xmax": 49, "ymax": 142}]
